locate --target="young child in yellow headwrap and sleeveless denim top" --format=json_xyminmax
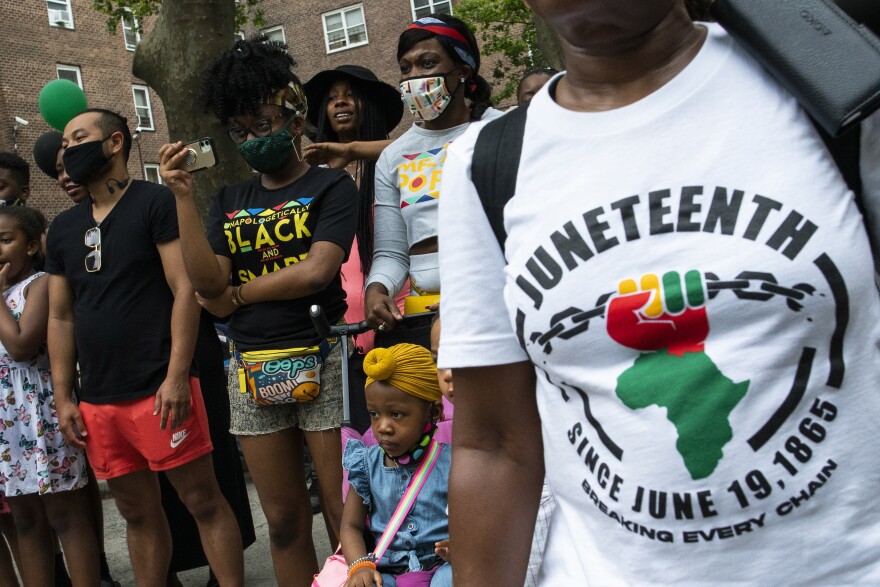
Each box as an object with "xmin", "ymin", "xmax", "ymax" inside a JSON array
[{"xmin": 340, "ymin": 344, "xmax": 452, "ymax": 587}]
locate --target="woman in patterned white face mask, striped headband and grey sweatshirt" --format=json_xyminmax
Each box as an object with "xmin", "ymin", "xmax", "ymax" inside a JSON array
[{"xmin": 365, "ymin": 14, "xmax": 501, "ymax": 330}]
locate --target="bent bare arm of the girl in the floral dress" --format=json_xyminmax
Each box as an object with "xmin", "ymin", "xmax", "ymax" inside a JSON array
[{"xmin": 0, "ymin": 272, "xmax": 49, "ymax": 361}]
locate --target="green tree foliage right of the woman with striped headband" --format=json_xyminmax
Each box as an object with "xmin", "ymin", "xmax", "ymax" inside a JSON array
[{"xmin": 455, "ymin": 0, "xmax": 551, "ymax": 102}]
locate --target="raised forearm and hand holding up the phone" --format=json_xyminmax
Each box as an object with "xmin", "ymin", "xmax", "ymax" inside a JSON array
[{"xmin": 159, "ymin": 142, "xmax": 232, "ymax": 299}]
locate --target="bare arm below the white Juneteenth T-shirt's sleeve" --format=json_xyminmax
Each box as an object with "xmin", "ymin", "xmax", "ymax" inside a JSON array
[{"xmin": 443, "ymin": 360, "xmax": 544, "ymax": 587}]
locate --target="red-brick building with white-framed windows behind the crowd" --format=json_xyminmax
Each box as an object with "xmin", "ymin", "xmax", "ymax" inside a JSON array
[{"xmin": 0, "ymin": 0, "xmax": 489, "ymax": 218}]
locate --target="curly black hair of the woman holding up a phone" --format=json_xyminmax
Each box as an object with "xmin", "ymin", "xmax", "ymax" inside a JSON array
[{"xmin": 197, "ymin": 33, "xmax": 302, "ymax": 124}]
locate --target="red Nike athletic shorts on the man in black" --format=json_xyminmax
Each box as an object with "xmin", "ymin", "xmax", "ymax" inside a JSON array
[{"xmin": 79, "ymin": 377, "xmax": 214, "ymax": 479}]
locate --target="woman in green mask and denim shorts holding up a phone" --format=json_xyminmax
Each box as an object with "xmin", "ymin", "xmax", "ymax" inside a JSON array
[{"xmin": 160, "ymin": 35, "xmax": 357, "ymax": 586}]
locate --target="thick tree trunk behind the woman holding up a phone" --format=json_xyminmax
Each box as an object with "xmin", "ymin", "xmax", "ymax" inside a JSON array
[{"xmin": 132, "ymin": 0, "xmax": 250, "ymax": 216}]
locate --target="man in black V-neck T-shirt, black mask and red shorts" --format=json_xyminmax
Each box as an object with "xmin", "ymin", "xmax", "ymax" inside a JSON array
[{"xmin": 46, "ymin": 109, "xmax": 243, "ymax": 585}]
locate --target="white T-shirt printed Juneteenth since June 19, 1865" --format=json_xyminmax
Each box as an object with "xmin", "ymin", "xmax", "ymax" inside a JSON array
[{"xmin": 439, "ymin": 25, "xmax": 880, "ymax": 587}]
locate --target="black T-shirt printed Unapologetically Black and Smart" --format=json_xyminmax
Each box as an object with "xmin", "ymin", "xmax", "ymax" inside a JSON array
[{"xmin": 207, "ymin": 167, "xmax": 357, "ymax": 350}]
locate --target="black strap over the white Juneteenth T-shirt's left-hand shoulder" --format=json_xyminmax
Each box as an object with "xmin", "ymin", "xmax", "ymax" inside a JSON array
[{"xmin": 471, "ymin": 104, "xmax": 528, "ymax": 251}]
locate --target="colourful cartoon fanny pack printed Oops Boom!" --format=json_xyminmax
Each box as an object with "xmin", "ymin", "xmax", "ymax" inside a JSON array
[{"xmin": 238, "ymin": 338, "xmax": 339, "ymax": 406}]
